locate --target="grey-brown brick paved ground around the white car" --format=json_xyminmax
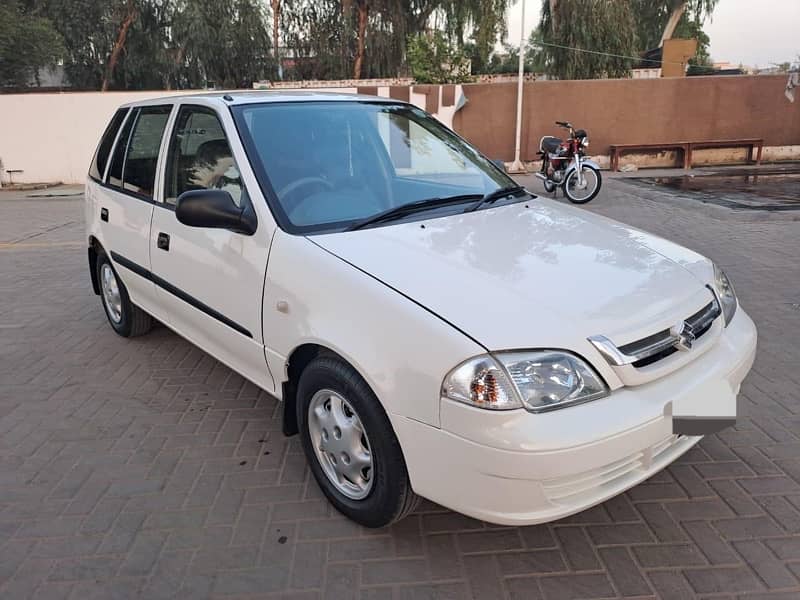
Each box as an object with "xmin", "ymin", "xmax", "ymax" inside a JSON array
[{"xmin": 0, "ymin": 175, "xmax": 800, "ymax": 600}]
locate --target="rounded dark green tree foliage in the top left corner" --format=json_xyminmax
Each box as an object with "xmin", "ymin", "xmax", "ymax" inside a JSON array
[{"xmin": 0, "ymin": 0, "xmax": 64, "ymax": 87}]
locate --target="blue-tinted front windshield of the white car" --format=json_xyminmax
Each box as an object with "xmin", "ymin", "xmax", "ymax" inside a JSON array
[{"xmin": 234, "ymin": 101, "xmax": 514, "ymax": 233}]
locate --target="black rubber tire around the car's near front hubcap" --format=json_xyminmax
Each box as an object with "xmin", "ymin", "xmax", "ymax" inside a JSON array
[{"xmin": 297, "ymin": 355, "xmax": 421, "ymax": 527}]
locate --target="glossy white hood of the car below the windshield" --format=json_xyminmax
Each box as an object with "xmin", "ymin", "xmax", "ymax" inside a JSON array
[{"xmin": 311, "ymin": 198, "xmax": 711, "ymax": 352}]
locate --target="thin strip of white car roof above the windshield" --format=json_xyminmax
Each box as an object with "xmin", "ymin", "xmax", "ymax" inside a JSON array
[{"xmin": 122, "ymin": 90, "xmax": 404, "ymax": 107}]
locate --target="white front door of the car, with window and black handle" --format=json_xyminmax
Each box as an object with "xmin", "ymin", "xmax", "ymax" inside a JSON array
[{"xmin": 150, "ymin": 105, "xmax": 275, "ymax": 390}]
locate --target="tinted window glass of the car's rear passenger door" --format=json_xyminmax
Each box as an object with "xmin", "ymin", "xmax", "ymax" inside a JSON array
[{"xmin": 108, "ymin": 106, "xmax": 172, "ymax": 200}]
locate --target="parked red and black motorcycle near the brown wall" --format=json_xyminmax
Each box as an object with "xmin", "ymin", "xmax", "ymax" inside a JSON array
[{"xmin": 536, "ymin": 121, "xmax": 603, "ymax": 204}]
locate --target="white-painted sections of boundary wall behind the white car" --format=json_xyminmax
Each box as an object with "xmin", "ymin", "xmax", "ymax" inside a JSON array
[{"xmin": 0, "ymin": 86, "xmax": 461, "ymax": 185}]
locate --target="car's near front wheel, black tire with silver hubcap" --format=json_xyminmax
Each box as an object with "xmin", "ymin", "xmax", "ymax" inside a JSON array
[{"xmin": 297, "ymin": 356, "xmax": 419, "ymax": 527}]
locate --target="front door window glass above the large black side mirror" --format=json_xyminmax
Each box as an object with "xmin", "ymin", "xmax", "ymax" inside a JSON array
[{"xmin": 164, "ymin": 106, "xmax": 244, "ymax": 206}]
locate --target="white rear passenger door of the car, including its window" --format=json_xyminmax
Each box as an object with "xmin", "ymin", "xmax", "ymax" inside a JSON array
[{"xmin": 95, "ymin": 105, "xmax": 172, "ymax": 316}]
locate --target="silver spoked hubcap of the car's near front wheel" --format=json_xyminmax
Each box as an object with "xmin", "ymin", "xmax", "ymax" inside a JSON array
[{"xmin": 308, "ymin": 390, "xmax": 373, "ymax": 500}]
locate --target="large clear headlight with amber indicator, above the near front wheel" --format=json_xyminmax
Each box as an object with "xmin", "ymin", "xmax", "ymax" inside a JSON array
[{"xmin": 442, "ymin": 350, "xmax": 608, "ymax": 412}]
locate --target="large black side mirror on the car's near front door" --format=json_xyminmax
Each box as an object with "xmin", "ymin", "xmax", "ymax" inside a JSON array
[{"xmin": 175, "ymin": 190, "xmax": 258, "ymax": 235}]
